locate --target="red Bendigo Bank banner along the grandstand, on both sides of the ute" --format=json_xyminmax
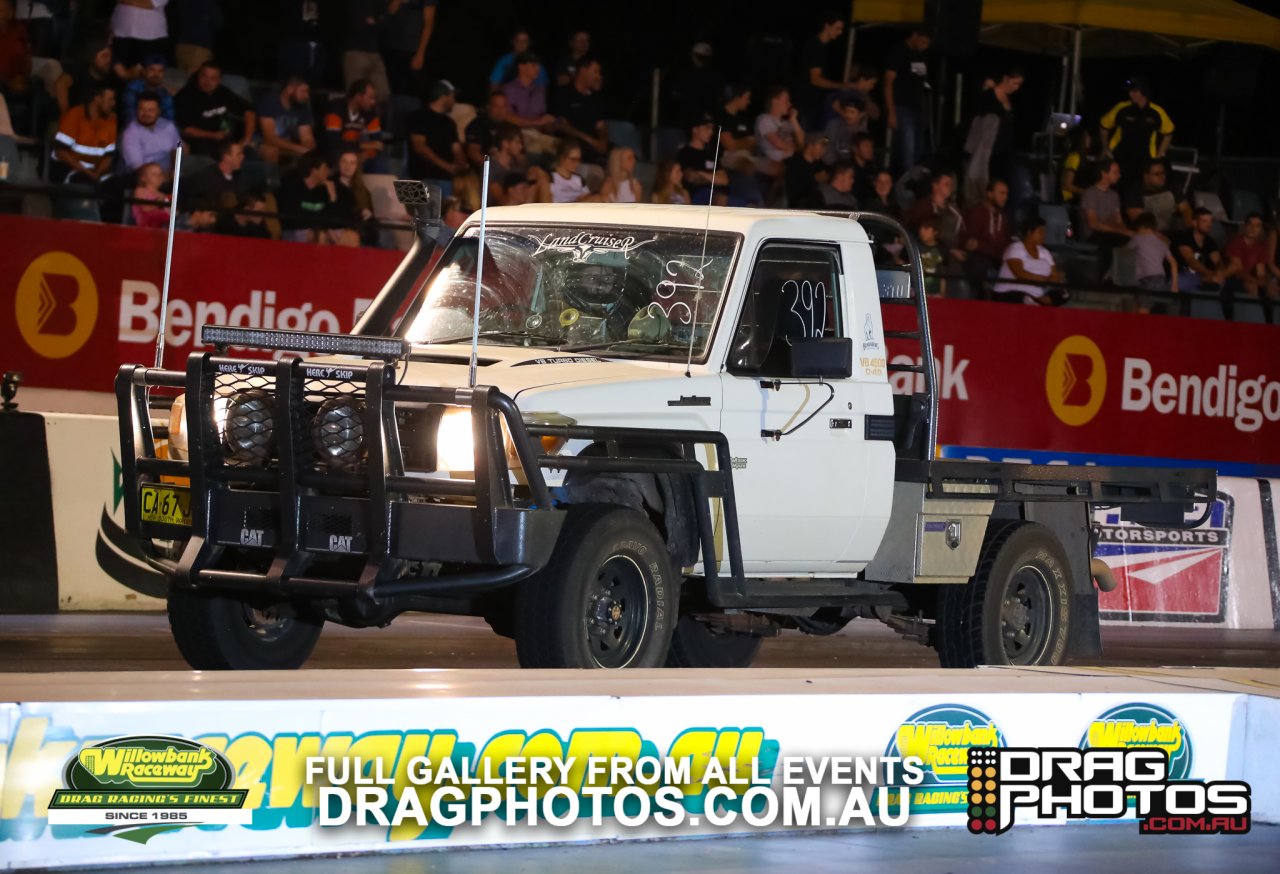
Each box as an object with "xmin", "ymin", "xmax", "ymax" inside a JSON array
[{"xmin": 0, "ymin": 216, "xmax": 1280, "ymax": 476}]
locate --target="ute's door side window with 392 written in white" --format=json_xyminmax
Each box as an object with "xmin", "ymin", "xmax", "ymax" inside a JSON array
[{"xmin": 728, "ymin": 243, "xmax": 845, "ymax": 377}]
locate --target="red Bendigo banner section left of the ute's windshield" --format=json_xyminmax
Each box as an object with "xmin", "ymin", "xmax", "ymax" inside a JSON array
[{"xmin": 0, "ymin": 215, "xmax": 401, "ymax": 392}]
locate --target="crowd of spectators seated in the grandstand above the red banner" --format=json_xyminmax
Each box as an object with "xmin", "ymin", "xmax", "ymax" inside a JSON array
[{"xmin": 0, "ymin": 0, "xmax": 1280, "ymax": 321}]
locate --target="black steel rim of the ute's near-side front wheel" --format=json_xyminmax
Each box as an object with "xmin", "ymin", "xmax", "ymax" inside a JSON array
[{"xmin": 585, "ymin": 555, "xmax": 649, "ymax": 668}]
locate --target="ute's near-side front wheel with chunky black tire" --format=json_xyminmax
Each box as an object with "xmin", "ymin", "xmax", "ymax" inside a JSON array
[{"xmin": 516, "ymin": 504, "xmax": 680, "ymax": 668}]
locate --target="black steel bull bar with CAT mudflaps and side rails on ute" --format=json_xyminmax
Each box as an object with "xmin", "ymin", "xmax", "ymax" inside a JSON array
[{"xmin": 115, "ymin": 353, "xmax": 742, "ymax": 598}]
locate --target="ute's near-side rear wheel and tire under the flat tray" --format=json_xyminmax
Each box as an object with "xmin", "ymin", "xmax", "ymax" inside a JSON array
[{"xmin": 937, "ymin": 522, "xmax": 1071, "ymax": 668}]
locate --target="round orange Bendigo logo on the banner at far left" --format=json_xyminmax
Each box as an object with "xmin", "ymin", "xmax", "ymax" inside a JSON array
[{"xmin": 14, "ymin": 252, "xmax": 97, "ymax": 358}]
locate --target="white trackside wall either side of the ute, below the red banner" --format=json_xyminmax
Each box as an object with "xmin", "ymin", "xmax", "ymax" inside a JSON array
[{"xmin": 0, "ymin": 413, "xmax": 1280, "ymax": 628}]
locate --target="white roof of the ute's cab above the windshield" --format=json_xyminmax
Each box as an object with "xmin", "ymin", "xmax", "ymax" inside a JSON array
[{"xmin": 467, "ymin": 203, "xmax": 867, "ymax": 242}]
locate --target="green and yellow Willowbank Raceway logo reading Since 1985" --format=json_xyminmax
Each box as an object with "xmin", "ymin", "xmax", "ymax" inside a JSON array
[{"xmin": 49, "ymin": 735, "xmax": 253, "ymax": 843}]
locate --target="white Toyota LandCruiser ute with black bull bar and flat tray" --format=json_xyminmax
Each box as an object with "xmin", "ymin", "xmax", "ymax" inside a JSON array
[{"xmin": 116, "ymin": 183, "xmax": 1216, "ymax": 668}]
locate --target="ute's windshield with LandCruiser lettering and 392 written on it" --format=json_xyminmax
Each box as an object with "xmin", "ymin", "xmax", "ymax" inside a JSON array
[{"xmin": 402, "ymin": 225, "xmax": 740, "ymax": 361}]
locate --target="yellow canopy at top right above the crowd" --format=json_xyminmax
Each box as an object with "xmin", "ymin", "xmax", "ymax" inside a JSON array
[{"xmin": 854, "ymin": 0, "xmax": 1280, "ymax": 49}]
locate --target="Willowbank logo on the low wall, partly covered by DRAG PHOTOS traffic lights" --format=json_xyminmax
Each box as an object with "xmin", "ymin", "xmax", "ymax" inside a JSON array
[{"xmin": 882, "ymin": 704, "xmax": 1006, "ymax": 814}]
